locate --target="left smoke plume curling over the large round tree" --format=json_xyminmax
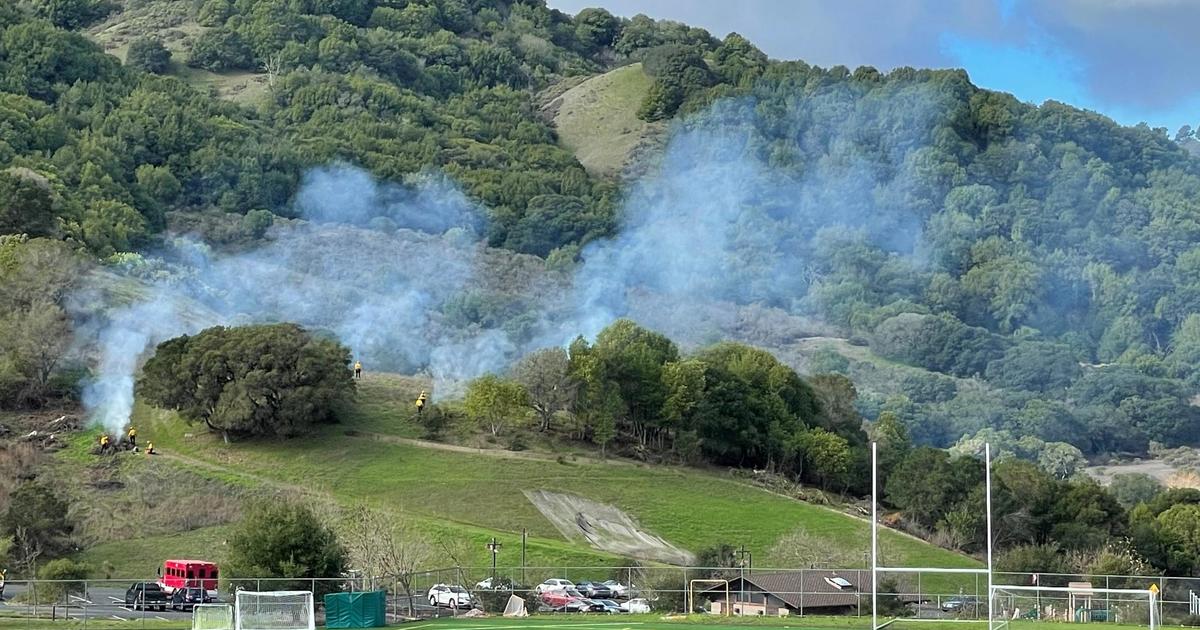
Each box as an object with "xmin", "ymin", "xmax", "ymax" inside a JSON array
[{"xmin": 73, "ymin": 166, "xmax": 514, "ymax": 433}]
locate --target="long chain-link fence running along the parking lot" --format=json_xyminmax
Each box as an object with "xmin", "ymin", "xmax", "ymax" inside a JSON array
[{"xmin": 0, "ymin": 566, "xmax": 1200, "ymax": 624}]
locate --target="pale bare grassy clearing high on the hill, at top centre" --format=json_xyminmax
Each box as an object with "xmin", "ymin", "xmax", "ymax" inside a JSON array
[{"xmin": 550, "ymin": 64, "xmax": 661, "ymax": 175}]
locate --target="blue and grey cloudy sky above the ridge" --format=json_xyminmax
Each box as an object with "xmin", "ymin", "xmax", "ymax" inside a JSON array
[{"xmin": 548, "ymin": 0, "xmax": 1200, "ymax": 136}]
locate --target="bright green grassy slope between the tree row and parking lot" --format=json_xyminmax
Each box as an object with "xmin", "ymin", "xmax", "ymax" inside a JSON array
[{"xmin": 110, "ymin": 376, "xmax": 974, "ymax": 585}]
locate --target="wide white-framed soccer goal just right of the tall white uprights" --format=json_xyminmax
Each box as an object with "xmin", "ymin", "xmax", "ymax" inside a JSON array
[{"xmin": 988, "ymin": 582, "xmax": 1160, "ymax": 630}]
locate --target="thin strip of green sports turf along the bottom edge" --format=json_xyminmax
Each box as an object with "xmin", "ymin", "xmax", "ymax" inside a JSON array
[{"xmin": 0, "ymin": 614, "xmax": 1146, "ymax": 630}]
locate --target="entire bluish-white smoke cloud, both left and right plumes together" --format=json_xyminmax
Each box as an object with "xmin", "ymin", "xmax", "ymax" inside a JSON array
[{"xmin": 76, "ymin": 83, "xmax": 940, "ymax": 432}]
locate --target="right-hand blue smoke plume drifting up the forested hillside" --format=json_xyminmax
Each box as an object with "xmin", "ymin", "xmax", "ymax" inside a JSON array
[{"xmin": 564, "ymin": 90, "xmax": 940, "ymax": 342}]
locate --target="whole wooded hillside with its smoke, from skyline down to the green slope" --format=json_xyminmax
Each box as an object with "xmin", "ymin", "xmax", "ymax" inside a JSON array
[{"xmin": 9, "ymin": 0, "xmax": 1200, "ymax": 585}]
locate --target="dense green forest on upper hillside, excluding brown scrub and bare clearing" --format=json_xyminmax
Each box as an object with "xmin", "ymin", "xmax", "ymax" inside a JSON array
[{"xmin": 7, "ymin": 0, "xmax": 1200, "ymax": 454}]
